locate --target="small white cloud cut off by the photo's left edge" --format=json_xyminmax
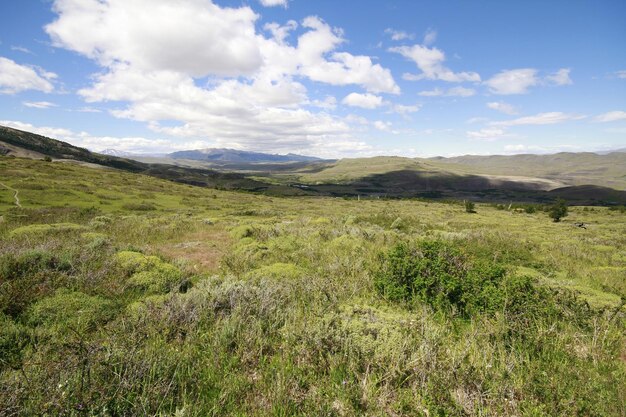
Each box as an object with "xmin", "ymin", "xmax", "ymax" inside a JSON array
[{"xmin": 0, "ymin": 57, "xmax": 56, "ymax": 94}]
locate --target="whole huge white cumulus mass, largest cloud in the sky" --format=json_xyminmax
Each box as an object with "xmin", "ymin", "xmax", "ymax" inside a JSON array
[{"xmin": 46, "ymin": 0, "xmax": 400, "ymax": 153}]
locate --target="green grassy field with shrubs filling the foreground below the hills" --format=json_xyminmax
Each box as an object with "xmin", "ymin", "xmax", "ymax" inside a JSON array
[{"xmin": 0, "ymin": 158, "xmax": 626, "ymax": 416}]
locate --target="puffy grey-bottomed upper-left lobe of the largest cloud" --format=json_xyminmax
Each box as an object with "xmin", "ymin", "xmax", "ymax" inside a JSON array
[{"xmin": 45, "ymin": 0, "xmax": 263, "ymax": 77}]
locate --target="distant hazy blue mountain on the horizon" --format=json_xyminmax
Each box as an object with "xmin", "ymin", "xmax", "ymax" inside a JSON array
[{"xmin": 167, "ymin": 148, "xmax": 321, "ymax": 164}]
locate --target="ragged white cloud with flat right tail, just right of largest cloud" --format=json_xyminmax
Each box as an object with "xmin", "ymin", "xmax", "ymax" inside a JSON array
[{"xmin": 389, "ymin": 44, "xmax": 480, "ymax": 82}]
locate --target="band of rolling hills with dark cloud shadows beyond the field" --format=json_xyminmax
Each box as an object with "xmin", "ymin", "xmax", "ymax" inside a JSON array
[{"xmin": 0, "ymin": 127, "xmax": 626, "ymax": 205}]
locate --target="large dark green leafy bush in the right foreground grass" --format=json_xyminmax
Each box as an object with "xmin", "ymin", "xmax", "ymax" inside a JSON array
[{"xmin": 376, "ymin": 241, "xmax": 544, "ymax": 317}]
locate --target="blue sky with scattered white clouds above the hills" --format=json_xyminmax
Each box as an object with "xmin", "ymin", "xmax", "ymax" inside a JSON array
[{"xmin": 0, "ymin": 0, "xmax": 626, "ymax": 158}]
